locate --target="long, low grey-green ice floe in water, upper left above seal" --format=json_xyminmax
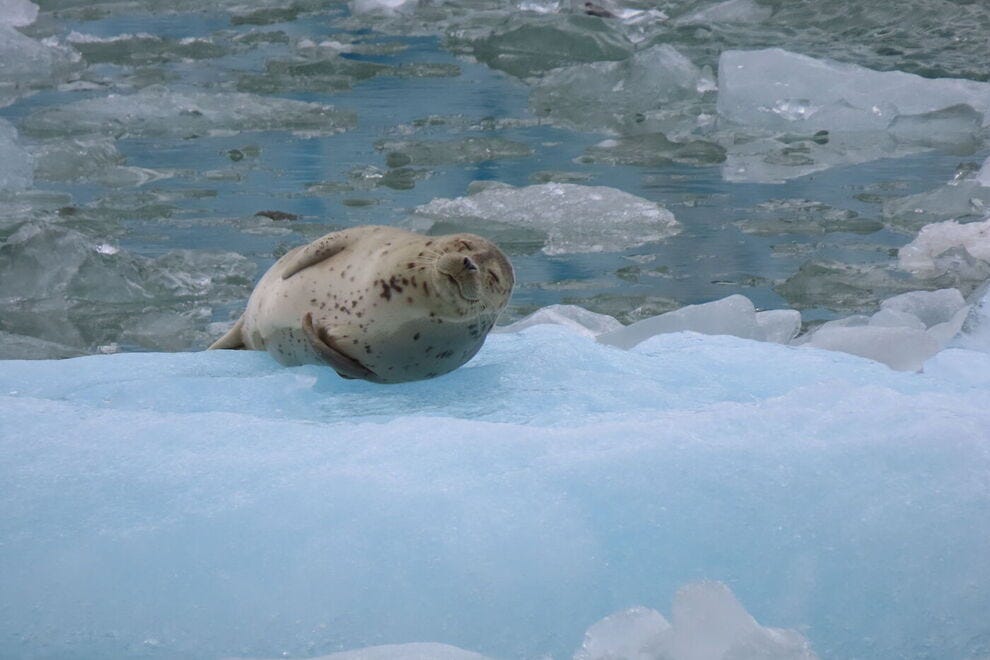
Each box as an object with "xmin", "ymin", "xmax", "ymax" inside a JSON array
[{"xmin": 21, "ymin": 85, "xmax": 357, "ymax": 137}]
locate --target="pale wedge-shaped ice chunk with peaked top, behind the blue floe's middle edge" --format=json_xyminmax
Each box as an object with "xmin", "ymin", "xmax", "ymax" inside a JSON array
[{"xmin": 598, "ymin": 294, "xmax": 801, "ymax": 348}]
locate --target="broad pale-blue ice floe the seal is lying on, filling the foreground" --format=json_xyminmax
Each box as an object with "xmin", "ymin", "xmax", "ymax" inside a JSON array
[{"xmin": 0, "ymin": 326, "xmax": 990, "ymax": 658}]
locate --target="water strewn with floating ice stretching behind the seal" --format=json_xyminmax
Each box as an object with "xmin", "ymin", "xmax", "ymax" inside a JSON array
[{"xmin": 0, "ymin": 0, "xmax": 987, "ymax": 357}]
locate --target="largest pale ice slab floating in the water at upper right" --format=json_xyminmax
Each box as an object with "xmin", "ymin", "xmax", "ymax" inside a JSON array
[{"xmin": 716, "ymin": 48, "xmax": 990, "ymax": 182}]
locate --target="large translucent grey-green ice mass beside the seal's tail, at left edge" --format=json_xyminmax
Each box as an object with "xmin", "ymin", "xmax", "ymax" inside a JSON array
[{"xmin": 0, "ymin": 220, "xmax": 255, "ymax": 357}]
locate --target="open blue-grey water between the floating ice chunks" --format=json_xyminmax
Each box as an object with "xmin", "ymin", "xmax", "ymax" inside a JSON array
[{"xmin": 0, "ymin": 3, "xmax": 986, "ymax": 351}]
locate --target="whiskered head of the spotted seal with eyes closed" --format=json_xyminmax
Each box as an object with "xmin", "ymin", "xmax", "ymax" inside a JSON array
[{"xmin": 432, "ymin": 234, "xmax": 515, "ymax": 319}]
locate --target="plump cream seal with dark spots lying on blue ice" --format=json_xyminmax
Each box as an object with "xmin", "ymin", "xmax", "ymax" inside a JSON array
[{"xmin": 210, "ymin": 226, "xmax": 515, "ymax": 383}]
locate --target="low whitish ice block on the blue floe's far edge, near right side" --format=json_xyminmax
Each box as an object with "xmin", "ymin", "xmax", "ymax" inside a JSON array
[{"xmin": 804, "ymin": 325, "xmax": 941, "ymax": 371}]
